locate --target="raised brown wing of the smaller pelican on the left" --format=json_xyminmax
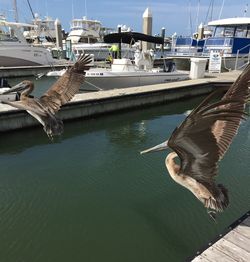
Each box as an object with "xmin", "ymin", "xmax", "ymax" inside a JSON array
[{"xmin": 40, "ymin": 55, "xmax": 91, "ymax": 114}]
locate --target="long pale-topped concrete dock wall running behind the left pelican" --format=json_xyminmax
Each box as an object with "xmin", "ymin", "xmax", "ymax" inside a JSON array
[{"xmin": 0, "ymin": 70, "xmax": 239, "ymax": 132}]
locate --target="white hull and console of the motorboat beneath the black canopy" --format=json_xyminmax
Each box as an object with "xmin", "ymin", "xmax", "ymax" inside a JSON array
[{"xmin": 47, "ymin": 50, "xmax": 189, "ymax": 91}]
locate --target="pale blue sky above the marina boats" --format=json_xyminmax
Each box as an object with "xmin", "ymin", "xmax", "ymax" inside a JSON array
[{"xmin": 0, "ymin": 0, "xmax": 250, "ymax": 35}]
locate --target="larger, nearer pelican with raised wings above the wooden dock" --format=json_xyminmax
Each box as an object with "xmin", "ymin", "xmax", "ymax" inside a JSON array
[{"xmin": 141, "ymin": 65, "xmax": 250, "ymax": 219}]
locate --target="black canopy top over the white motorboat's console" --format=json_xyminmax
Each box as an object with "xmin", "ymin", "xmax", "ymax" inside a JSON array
[{"xmin": 104, "ymin": 32, "xmax": 164, "ymax": 44}]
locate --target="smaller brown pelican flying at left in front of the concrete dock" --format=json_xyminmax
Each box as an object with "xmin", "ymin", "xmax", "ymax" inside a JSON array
[{"xmin": 2, "ymin": 55, "xmax": 91, "ymax": 139}]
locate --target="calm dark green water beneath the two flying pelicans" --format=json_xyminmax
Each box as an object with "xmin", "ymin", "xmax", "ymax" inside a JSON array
[{"xmin": 0, "ymin": 94, "xmax": 250, "ymax": 262}]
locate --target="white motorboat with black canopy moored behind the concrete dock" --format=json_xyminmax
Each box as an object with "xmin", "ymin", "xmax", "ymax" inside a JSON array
[{"xmin": 75, "ymin": 32, "xmax": 189, "ymax": 90}]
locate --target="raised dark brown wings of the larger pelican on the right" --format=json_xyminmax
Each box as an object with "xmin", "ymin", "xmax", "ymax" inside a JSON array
[{"xmin": 168, "ymin": 66, "xmax": 250, "ymax": 185}]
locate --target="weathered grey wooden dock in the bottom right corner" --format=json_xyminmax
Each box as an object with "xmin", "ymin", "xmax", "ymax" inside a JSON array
[{"xmin": 188, "ymin": 211, "xmax": 250, "ymax": 262}]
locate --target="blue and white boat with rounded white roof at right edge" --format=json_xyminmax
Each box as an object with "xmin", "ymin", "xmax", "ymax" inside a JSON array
[{"xmin": 168, "ymin": 17, "xmax": 250, "ymax": 71}]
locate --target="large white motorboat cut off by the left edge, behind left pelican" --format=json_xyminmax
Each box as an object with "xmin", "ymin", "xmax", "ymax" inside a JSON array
[{"xmin": 0, "ymin": 20, "xmax": 59, "ymax": 67}]
